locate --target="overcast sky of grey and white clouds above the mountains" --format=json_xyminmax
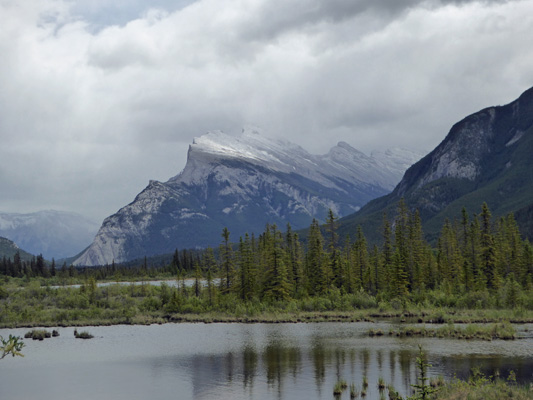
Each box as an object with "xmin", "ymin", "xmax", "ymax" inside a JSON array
[{"xmin": 0, "ymin": 0, "xmax": 533, "ymax": 222}]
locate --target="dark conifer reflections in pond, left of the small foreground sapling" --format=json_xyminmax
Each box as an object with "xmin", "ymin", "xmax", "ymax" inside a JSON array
[{"xmin": 169, "ymin": 339, "xmax": 416, "ymax": 399}]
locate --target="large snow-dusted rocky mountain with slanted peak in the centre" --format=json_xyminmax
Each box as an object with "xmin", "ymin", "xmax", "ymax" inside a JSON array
[{"xmin": 75, "ymin": 128, "xmax": 418, "ymax": 265}]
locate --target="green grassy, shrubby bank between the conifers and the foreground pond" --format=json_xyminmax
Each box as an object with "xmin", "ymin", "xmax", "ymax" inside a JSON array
[{"xmin": 0, "ymin": 279, "xmax": 533, "ymax": 330}]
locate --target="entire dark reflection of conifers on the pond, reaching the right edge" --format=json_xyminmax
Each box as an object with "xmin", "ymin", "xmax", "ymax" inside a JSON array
[{"xmin": 170, "ymin": 338, "xmax": 532, "ymax": 399}]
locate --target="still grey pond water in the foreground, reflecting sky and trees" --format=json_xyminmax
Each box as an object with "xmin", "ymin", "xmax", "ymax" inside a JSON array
[{"xmin": 0, "ymin": 323, "xmax": 533, "ymax": 400}]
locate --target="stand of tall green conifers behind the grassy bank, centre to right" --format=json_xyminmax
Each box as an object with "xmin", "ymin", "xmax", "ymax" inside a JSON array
[{"xmin": 187, "ymin": 200, "xmax": 533, "ymax": 305}]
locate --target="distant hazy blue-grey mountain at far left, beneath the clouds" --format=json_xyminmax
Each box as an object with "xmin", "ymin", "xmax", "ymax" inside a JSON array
[{"xmin": 0, "ymin": 211, "xmax": 98, "ymax": 260}]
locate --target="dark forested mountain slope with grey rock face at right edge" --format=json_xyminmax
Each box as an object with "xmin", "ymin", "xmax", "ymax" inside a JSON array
[{"xmin": 340, "ymin": 88, "xmax": 533, "ymax": 240}]
